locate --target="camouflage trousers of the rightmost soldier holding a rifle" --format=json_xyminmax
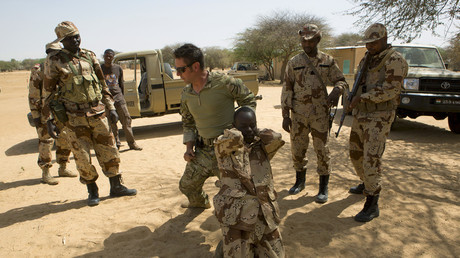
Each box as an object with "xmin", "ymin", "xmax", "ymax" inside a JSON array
[{"xmin": 350, "ymin": 111, "xmax": 395, "ymax": 195}]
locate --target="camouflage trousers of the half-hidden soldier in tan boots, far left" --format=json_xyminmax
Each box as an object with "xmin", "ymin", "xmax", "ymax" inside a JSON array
[{"xmin": 36, "ymin": 124, "xmax": 70, "ymax": 168}]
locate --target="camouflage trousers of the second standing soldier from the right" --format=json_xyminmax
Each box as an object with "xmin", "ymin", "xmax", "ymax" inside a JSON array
[{"xmin": 291, "ymin": 112, "xmax": 331, "ymax": 175}]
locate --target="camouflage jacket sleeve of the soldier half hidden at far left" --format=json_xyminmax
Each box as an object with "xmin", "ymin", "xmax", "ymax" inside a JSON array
[{"xmin": 29, "ymin": 66, "xmax": 45, "ymax": 122}]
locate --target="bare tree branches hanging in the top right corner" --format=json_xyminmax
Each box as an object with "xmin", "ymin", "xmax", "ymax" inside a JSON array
[{"xmin": 347, "ymin": 0, "xmax": 460, "ymax": 42}]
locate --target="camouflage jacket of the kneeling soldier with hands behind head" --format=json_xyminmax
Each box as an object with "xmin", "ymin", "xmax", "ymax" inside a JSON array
[{"xmin": 214, "ymin": 128, "xmax": 284, "ymax": 236}]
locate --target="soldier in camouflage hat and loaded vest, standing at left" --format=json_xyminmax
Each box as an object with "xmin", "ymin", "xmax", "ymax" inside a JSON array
[{"xmin": 43, "ymin": 21, "xmax": 137, "ymax": 206}]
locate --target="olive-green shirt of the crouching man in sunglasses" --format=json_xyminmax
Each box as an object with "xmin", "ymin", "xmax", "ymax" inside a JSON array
[{"xmin": 180, "ymin": 72, "xmax": 256, "ymax": 143}]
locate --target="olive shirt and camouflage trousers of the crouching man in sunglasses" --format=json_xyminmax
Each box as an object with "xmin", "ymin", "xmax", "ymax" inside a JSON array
[{"xmin": 179, "ymin": 72, "xmax": 256, "ymax": 207}]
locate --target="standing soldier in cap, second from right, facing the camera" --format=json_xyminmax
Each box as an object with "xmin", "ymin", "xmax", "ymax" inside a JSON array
[{"xmin": 281, "ymin": 24, "xmax": 348, "ymax": 203}]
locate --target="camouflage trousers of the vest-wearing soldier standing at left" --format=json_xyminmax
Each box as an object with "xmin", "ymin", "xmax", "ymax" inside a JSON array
[{"xmin": 67, "ymin": 113, "xmax": 120, "ymax": 184}]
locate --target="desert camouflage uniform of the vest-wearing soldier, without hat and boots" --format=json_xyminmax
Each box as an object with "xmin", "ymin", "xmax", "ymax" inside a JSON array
[{"xmin": 45, "ymin": 49, "xmax": 120, "ymax": 184}]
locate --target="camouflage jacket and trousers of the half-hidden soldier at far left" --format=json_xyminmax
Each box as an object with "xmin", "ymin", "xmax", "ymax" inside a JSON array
[{"xmin": 29, "ymin": 67, "xmax": 70, "ymax": 168}]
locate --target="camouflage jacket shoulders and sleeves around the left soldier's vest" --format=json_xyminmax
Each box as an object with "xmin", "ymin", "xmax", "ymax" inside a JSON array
[{"xmin": 42, "ymin": 49, "xmax": 115, "ymax": 117}]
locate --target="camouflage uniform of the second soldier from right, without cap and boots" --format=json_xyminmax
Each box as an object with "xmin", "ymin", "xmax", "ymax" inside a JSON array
[{"xmin": 281, "ymin": 51, "xmax": 348, "ymax": 175}]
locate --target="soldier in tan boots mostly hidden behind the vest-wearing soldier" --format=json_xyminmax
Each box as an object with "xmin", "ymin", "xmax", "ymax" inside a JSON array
[{"xmin": 29, "ymin": 64, "xmax": 77, "ymax": 185}]
